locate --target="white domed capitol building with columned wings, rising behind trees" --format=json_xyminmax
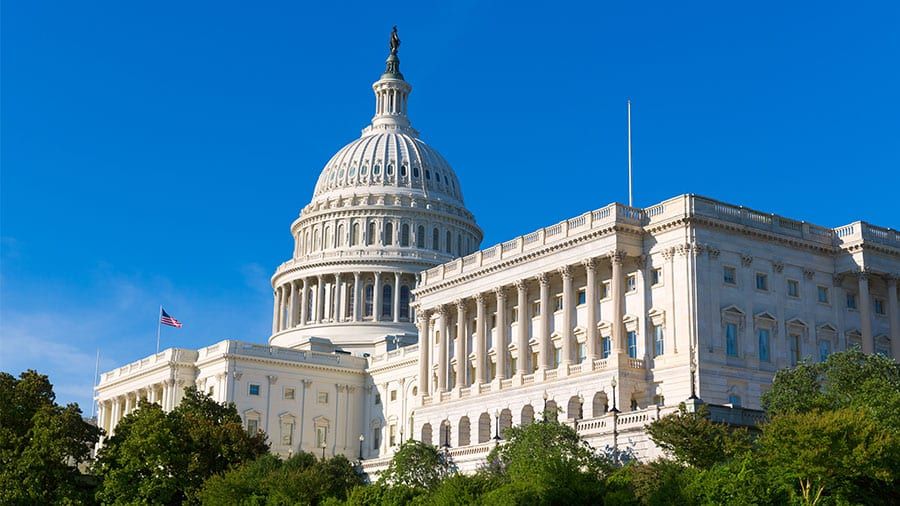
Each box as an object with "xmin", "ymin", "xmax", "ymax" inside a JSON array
[{"xmin": 95, "ymin": 35, "xmax": 900, "ymax": 476}]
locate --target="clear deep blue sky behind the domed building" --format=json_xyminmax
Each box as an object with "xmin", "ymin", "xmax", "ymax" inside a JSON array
[{"xmin": 0, "ymin": 1, "xmax": 900, "ymax": 411}]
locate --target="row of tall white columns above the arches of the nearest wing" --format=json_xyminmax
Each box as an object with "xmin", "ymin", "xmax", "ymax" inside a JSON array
[{"xmin": 417, "ymin": 251, "xmax": 626, "ymax": 392}]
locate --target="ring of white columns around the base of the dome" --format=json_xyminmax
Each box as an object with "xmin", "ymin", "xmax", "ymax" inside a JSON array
[{"xmin": 272, "ymin": 272, "xmax": 413, "ymax": 334}]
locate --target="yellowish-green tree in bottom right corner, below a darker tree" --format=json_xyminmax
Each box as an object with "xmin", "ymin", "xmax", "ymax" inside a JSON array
[{"xmin": 759, "ymin": 408, "xmax": 900, "ymax": 504}]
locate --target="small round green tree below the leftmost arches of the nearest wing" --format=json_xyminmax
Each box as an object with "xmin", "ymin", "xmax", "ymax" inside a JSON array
[{"xmin": 378, "ymin": 439, "xmax": 452, "ymax": 490}]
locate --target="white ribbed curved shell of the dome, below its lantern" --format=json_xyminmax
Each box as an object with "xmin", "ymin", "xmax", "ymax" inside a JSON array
[{"xmin": 313, "ymin": 129, "xmax": 463, "ymax": 205}]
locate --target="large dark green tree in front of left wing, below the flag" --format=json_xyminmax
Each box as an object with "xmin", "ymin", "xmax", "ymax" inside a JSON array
[{"xmin": 95, "ymin": 387, "xmax": 268, "ymax": 504}]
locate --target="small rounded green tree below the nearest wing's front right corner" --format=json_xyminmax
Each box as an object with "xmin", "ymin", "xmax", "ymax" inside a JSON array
[{"xmin": 647, "ymin": 403, "xmax": 752, "ymax": 469}]
